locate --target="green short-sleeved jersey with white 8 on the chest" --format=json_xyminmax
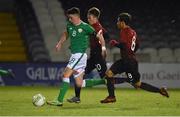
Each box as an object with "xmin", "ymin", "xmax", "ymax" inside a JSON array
[{"xmin": 66, "ymin": 22, "xmax": 95, "ymax": 54}]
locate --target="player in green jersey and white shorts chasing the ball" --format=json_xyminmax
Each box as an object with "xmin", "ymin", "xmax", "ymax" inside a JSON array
[{"xmin": 47, "ymin": 7, "xmax": 106, "ymax": 106}]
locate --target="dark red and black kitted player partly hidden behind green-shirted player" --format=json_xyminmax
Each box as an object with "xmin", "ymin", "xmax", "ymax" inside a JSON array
[{"xmin": 67, "ymin": 7, "xmax": 109, "ymax": 103}]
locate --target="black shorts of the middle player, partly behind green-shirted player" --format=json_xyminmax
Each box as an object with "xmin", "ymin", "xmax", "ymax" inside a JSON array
[{"xmin": 85, "ymin": 53, "xmax": 107, "ymax": 78}]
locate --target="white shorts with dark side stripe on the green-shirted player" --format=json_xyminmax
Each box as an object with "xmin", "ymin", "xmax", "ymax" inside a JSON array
[{"xmin": 67, "ymin": 53, "xmax": 87, "ymax": 78}]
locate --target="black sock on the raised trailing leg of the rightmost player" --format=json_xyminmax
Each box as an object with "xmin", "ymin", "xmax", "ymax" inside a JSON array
[{"xmin": 140, "ymin": 82, "xmax": 160, "ymax": 93}]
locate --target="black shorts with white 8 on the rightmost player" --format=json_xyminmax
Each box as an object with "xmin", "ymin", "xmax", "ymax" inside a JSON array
[{"xmin": 110, "ymin": 59, "xmax": 140, "ymax": 84}]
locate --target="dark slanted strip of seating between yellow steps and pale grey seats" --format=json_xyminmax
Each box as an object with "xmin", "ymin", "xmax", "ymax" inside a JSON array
[{"xmin": 16, "ymin": 0, "xmax": 51, "ymax": 62}]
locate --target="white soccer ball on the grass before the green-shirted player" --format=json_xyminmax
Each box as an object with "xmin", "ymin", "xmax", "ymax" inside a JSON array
[{"xmin": 32, "ymin": 93, "xmax": 46, "ymax": 107}]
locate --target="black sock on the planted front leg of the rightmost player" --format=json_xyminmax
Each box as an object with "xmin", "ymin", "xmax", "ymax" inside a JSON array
[{"xmin": 106, "ymin": 78, "xmax": 115, "ymax": 97}]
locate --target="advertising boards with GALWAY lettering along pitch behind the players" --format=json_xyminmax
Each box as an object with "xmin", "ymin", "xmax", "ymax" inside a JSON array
[{"xmin": 0, "ymin": 62, "xmax": 180, "ymax": 88}]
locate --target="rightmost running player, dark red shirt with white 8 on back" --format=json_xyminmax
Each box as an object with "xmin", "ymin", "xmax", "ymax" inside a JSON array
[{"xmin": 101, "ymin": 13, "xmax": 169, "ymax": 103}]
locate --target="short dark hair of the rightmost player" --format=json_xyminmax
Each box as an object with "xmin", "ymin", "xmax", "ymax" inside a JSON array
[{"xmin": 118, "ymin": 13, "xmax": 132, "ymax": 25}]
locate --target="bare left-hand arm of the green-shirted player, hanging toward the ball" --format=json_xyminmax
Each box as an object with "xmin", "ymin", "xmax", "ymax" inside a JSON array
[{"xmin": 56, "ymin": 31, "xmax": 68, "ymax": 51}]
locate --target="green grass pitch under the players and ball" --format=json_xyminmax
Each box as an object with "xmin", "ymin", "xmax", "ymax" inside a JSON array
[{"xmin": 0, "ymin": 87, "xmax": 180, "ymax": 116}]
